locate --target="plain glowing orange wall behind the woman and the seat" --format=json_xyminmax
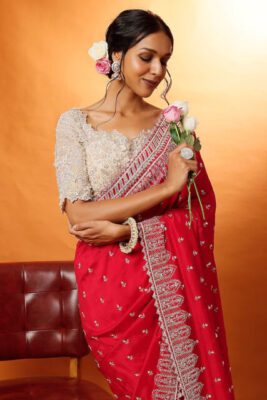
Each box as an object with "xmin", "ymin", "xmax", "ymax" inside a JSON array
[{"xmin": 0, "ymin": 0, "xmax": 267, "ymax": 400}]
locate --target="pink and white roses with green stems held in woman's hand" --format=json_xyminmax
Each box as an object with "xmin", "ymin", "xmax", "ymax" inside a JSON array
[{"xmin": 163, "ymin": 101, "xmax": 206, "ymax": 227}]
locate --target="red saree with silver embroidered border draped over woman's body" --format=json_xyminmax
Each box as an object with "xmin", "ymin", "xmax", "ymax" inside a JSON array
[{"xmin": 74, "ymin": 115, "xmax": 237, "ymax": 400}]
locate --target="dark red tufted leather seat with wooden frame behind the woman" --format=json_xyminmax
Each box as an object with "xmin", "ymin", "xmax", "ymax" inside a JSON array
[{"xmin": 0, "ymin": 261, "xmax": 113, "ymax": 400}]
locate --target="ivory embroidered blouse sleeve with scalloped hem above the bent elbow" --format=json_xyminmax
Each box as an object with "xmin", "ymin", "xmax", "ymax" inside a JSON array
[{"xmin": 54, "ymin": 110, "xmax": 93, "ymax": 213}]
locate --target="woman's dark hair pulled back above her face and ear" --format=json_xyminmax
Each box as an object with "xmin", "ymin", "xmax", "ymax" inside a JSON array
[{"xmin": 106, "ymin": 9, "xmax": 174, "ymax": 78}]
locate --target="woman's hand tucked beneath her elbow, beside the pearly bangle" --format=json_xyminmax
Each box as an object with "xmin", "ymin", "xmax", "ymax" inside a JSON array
[{"xmin": 68, "ymin": 220, "xmax": 130, "ymax": 246}]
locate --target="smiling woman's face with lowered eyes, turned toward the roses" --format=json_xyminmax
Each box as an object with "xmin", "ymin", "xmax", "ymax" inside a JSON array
[{"xmin": 118, "ymin": 31, "xmax": 172, "ymax": 97}]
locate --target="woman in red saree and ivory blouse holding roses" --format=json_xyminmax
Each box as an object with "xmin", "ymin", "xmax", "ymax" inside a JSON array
[{"xmin": 55, "ymin": 10, "xmax": 234, "ymax": 400}]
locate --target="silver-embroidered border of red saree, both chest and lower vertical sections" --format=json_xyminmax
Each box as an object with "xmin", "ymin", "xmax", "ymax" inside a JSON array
[{"xmin": 93, "ymin": 111, "xmax": 204, "ymax": 400}]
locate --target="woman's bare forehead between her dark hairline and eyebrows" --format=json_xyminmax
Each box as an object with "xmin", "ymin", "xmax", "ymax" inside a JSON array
[{"xmin": 133, "ymin": 31, "xmax": 172, "ymax": 55}]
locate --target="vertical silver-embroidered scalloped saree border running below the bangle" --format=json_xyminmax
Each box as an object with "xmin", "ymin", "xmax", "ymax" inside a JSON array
[{"xmin": 138, "ymin": 216, "xmax": 204, "ymax": 400}]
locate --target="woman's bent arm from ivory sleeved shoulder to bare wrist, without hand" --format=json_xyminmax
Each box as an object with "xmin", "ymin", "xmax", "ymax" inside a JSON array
[{"xmin": 54, "ymin": 110, "xmax": 173, "ymax": 228}]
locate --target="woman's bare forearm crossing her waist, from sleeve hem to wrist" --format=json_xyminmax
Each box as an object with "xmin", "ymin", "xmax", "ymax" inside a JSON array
[{"xmin": 66, "ymin": 182, "xmax": 172, "ymax": 224}]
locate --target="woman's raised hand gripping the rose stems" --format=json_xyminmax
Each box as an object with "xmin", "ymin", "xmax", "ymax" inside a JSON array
[{"xmin": 164, "ymin": 143, "xmax": 197, "ymax": 193}]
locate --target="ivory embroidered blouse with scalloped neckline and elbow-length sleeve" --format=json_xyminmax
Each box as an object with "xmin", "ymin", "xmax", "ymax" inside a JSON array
[{"xmin": 54, "ymin": 108, "xmax": 155, "ymax": 212}]
